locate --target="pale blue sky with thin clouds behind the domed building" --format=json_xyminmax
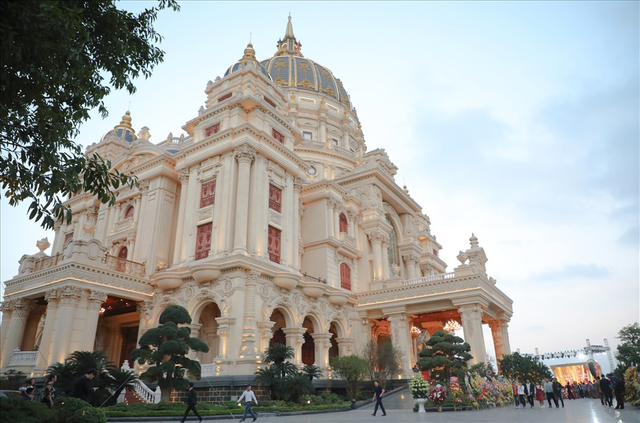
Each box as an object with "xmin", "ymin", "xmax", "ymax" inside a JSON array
[{"xmin": 1, "ymin": 2, "xmax": 640, "ymax": 362}]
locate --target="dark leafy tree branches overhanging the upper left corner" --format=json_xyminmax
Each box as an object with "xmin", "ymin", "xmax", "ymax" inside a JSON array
[{"xmin": 0, "ymin": 0, "xmax": 179, "ymax": 229}]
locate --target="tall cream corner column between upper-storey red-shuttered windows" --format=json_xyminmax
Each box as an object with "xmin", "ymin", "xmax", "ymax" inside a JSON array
[{"xmin": 233, "ymin": 144, "xmax": 256, "ymax": 255}]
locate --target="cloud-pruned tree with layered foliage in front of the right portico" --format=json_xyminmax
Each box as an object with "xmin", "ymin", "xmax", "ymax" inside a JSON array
[{"xmin": 418, "ymin": 330, "xmax": 473, "ymax": 382}]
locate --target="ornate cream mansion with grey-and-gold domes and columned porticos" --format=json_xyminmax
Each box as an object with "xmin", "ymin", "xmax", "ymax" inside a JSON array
[{"xmin": 0, "ymin": 18, "xmax": 512, "ymax": 377}]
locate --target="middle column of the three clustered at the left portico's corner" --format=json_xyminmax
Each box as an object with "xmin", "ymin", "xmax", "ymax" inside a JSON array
[{"xmin": 49, "ymin": 286, "xmax": 83, "ymax": 365}]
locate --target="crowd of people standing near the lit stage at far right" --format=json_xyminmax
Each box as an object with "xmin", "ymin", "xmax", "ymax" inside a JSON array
[{"xmin": 513, "ymin": 373, "xmax": 625, "ymax": 410}]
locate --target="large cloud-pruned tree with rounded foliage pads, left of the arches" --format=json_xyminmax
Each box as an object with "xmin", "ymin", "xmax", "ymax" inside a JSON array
[{"xmin": 129, "ymin": 305, "xmax": 209, "ymax": 402}]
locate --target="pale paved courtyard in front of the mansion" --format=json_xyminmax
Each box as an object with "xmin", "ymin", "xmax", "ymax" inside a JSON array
[{"xmin": 122, "ymin": 390, "xmax": 640, "ymax": 423}]
